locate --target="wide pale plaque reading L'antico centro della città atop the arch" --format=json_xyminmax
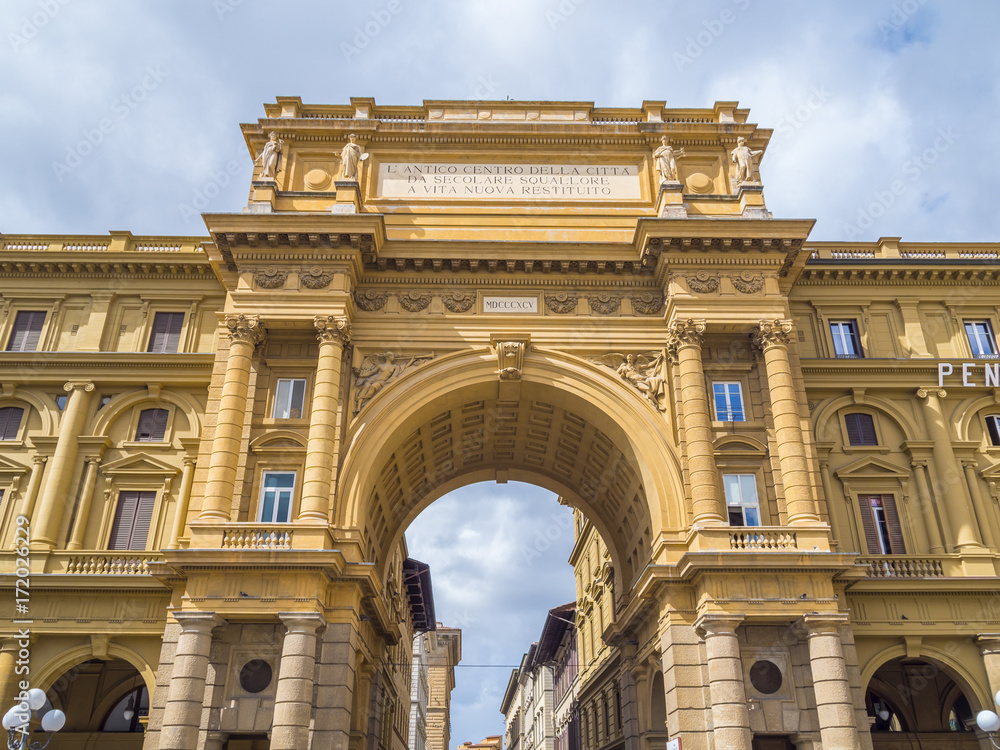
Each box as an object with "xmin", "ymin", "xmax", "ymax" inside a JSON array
[{"xmin": 378, "ymin": 162, "xmax": 642, "ymax": 200}]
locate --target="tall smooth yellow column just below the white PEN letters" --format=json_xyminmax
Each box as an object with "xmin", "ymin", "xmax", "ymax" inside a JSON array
[{"xmin": 917, "ymin": 388, "xmax": 983, "ymax": 550}]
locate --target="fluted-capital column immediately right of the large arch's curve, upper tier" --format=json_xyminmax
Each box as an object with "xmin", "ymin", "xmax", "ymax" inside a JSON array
[{"xmin": 667, "ymin": 320, "xmax": 726, "ymax": 526}]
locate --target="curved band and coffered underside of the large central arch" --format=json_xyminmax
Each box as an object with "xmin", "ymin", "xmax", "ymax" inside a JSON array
[{"xmin": 335, "ymin": 349, "xmax": 686, "ymax": 591}]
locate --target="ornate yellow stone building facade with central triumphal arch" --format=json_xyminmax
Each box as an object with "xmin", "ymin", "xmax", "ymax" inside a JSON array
[{"xmin": 0, "ymin": 98, "xmax": 1000, "ymax": 750}]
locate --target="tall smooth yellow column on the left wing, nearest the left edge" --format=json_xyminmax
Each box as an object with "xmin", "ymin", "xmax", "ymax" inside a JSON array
[{"xmin": 31, "ymin": 383, "xmax": 94, "ymax": 550}]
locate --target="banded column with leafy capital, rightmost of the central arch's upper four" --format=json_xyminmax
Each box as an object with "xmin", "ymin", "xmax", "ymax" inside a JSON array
[{"xmin": 750, "ymin": 320, "xmax": 819, "ymax": 526}]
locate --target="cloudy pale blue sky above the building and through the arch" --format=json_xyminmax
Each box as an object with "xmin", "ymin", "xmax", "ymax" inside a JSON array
[{"xmin": 0, "ymin": 0, "xmax": 1000, "ymax": 742}]
